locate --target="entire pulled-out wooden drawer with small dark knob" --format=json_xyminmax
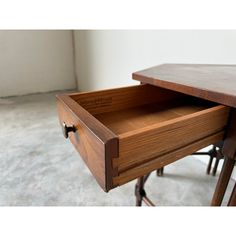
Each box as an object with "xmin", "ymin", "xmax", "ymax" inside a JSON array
[{"xmin": 57, "ymin": 85, "xmax": 229, "ymax": 191}]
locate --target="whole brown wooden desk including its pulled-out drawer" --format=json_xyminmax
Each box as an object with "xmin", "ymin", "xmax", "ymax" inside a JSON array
[{"xmin": 57, "ymin": 65, "xmax": 236, "ymax": 205}]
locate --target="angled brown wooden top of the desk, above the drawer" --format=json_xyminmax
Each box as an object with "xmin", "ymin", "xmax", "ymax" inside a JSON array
[{"xmin": 133, "ymin": 64, "xmax": 236, "ymax": 108}]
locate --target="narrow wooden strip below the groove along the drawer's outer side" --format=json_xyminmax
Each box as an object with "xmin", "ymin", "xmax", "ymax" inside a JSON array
[{"xmin": 113, "ymin": 131, "xmax": 224, "ymax": 185}]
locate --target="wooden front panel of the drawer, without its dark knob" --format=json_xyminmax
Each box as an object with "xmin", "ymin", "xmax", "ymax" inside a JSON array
[{"xmin": 57, "ymin": 95, "xmax": 118, "ymax": 191}]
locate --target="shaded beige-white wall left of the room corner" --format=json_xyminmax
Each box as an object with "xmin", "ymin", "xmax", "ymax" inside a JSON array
[{"xmin": 0, "ymin": 30, "xmax": 76, "ymax": 97}]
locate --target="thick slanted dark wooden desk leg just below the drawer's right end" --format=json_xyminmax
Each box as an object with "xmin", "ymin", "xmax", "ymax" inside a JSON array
[{"xmin": 211, "ymin": 157, "xmax": 235, "ymax": 206}]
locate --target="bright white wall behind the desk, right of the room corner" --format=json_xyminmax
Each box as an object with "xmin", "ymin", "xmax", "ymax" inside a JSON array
[{"xmin": 75, "ymin": 30, "xmax": 236, "ymax": 90}]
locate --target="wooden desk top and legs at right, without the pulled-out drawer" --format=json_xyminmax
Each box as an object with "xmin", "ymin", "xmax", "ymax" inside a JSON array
[{"xmin": 133, "ymin": 64, "xmax": 236, "ymax": 206}]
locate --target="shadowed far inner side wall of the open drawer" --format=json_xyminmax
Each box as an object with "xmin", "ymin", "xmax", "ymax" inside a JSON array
[{"xmin": 70, "ymin": 85, "xmax": 182, "ymax": 115}]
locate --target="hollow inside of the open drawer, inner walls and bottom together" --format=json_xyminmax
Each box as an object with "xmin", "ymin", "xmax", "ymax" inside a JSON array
[{"xmin": 72, "ymin": 85, "xmax": 218, "ymax": 137}]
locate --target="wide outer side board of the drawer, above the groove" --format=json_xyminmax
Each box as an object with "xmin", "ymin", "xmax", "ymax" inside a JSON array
[{"xmin": 113, "ymin": 105, "xmax": 229, "ymax": 172}]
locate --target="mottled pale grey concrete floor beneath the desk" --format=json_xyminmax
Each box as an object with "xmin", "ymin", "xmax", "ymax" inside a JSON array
[{"xmin": 0, "ymin": 93, "xmax": 233, "ymax": 206}]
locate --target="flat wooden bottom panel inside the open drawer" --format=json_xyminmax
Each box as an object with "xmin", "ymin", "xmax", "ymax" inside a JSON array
[{"xmin": 95, "ymin": 98, "xmax": 214, "ymax": 136}]
